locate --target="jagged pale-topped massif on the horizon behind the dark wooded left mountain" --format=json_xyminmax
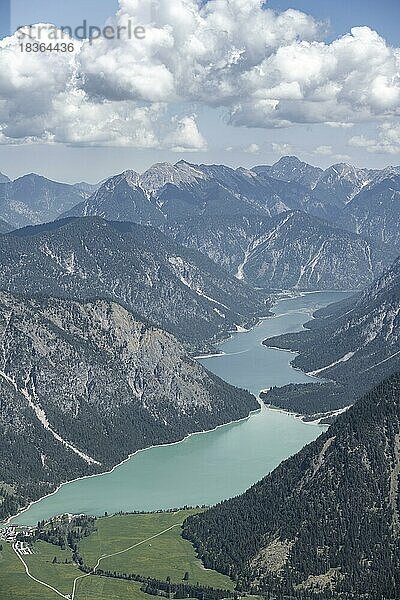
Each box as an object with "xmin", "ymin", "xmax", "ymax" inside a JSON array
[{"xmin": 63, "ymin": 161, "xmax": 308, "ymax": 225}]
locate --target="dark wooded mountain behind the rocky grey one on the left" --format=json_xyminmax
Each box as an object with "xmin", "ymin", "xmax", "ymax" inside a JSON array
[{"xmin": 0, "ymin": 218, "xmax": 267, "ymax": 349}]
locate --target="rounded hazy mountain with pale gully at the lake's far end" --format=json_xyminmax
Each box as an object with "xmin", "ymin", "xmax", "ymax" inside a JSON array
[{"xmin": 238, "ymin": 212, "xmax": 395, "ymax": 290}]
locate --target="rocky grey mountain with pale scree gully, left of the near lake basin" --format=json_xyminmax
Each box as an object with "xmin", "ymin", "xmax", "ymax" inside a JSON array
[{"xmin": 0, "ymin": 292, "xmax": 258, "ymax": 516}]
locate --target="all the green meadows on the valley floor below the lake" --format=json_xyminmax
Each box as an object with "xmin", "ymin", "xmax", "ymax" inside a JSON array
[{"xmin": 0, "ymin": 511, "xmax": 233, "ymax": 600}]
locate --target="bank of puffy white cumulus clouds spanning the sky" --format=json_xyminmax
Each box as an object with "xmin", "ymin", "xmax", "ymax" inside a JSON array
[{"xmin": 0, "ymin": 0, "xmax": 400, "ymax": 146}]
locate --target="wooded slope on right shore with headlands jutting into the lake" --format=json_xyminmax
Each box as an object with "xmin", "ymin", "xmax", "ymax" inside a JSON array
[{"xmin": 262, "ymin": 258, "xmax": 400, "ymax": 415}]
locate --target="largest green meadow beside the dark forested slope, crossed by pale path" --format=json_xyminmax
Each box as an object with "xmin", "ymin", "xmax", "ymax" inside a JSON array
[{"xmin": 79, "ymin": 511, "xmax": 233, "ymax": 589}]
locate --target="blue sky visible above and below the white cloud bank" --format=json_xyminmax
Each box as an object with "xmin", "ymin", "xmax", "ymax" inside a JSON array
[{"xmin": 0, "ymin": 0, "xmax": 400, "ymax": 181}]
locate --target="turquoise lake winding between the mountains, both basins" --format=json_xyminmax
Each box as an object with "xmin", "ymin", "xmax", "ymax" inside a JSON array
[{"xmin": 9, "ymin": 292, "xmax": 349, "ymax": 525}]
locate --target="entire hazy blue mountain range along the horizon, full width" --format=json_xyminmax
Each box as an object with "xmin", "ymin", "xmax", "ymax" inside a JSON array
[{"xmin": 0, "ymin": 156, "xmax": 400, "ymax": 289}]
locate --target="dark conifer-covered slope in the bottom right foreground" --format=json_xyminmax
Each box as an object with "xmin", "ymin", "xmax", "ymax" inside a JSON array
[{"xmin": 184, "ymin": 375, "xmax": 400, "ymax": 600}]
